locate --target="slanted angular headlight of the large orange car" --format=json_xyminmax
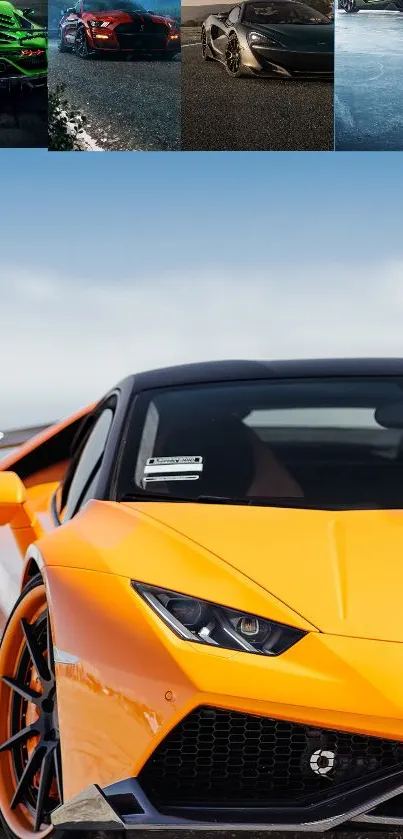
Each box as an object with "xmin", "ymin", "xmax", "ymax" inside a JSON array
[{"xmin": 132, "ymin": 580, "xmax": 306, "ymax": 655}]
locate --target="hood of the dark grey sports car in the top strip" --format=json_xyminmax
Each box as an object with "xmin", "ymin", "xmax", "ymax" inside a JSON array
[{"xmin": 247, "ymin": 23, "xmax": 334, "ymax": 52}]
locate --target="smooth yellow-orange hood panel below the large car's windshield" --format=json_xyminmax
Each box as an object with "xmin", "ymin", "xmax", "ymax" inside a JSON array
[{"xmin": 129, "ymin": 503, "xmax": 403, "ymax": 643}]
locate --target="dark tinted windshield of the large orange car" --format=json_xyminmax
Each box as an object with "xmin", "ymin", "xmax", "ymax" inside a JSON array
[{"xmin": 118, "ymin": 377, "xmax": 403, "ymax": 508}]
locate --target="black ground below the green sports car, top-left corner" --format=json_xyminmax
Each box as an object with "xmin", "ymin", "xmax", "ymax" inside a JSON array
[{"xmin": 0, "ymin": 89, "xmax": 48, "ymax": 149}]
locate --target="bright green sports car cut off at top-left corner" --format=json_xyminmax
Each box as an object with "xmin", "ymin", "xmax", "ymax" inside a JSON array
[{"xmin": 0, "ymin": 0, "xmax": 48, "ymax": 90}]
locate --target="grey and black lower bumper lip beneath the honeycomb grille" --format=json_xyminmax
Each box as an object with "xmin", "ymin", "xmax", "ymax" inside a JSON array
[{"xmin": 52, "ymin": 768, "xmax": 403, "ymax": 839}]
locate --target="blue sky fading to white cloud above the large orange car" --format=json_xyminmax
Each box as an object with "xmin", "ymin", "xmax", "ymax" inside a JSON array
[{"xmin": 0, "ymin": 150, "xmax": 403, "ymax": 429}]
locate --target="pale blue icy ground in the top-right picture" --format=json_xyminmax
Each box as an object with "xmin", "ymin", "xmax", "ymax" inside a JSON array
[{"xmin": 335, "ymin": 11, "xmax": 403, "ymax": 151}]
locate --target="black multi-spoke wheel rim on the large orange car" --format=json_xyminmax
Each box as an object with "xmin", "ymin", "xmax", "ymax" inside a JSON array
[{"xmin": 0, "ymin": 611, "xmax": 63, "ymax": 832}]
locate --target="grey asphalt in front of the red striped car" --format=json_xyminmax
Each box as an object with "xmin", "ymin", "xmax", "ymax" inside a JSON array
[{"xmin": 49, "ymin": 42, "xmax": 181, "ymax": 151}]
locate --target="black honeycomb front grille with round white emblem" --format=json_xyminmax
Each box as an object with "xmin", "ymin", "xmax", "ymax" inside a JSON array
[{"xmin": 139, "ymin": 707, "xmax": 403, "ymax": 811}]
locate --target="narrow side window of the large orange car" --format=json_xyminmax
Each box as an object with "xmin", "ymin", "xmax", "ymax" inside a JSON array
[{"xmin": 63, "ymin": 408, "xmax": 113, "ymax": 521}]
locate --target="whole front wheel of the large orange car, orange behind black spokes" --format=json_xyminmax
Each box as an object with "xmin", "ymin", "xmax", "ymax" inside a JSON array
[{"xmin": 0, "ymin": 575, "xmax": 63, "ymax": 839}]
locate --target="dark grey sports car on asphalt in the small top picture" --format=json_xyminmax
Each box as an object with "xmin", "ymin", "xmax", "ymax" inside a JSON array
[{"xmin": 201, "ymin": 0, "xmax": 334, "ymax": 79}]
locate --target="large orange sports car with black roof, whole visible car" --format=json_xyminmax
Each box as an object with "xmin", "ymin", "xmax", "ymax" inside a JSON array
[{"xmin": 0, "ymin": 359, "xmax": 403, "ymax": 839}]
